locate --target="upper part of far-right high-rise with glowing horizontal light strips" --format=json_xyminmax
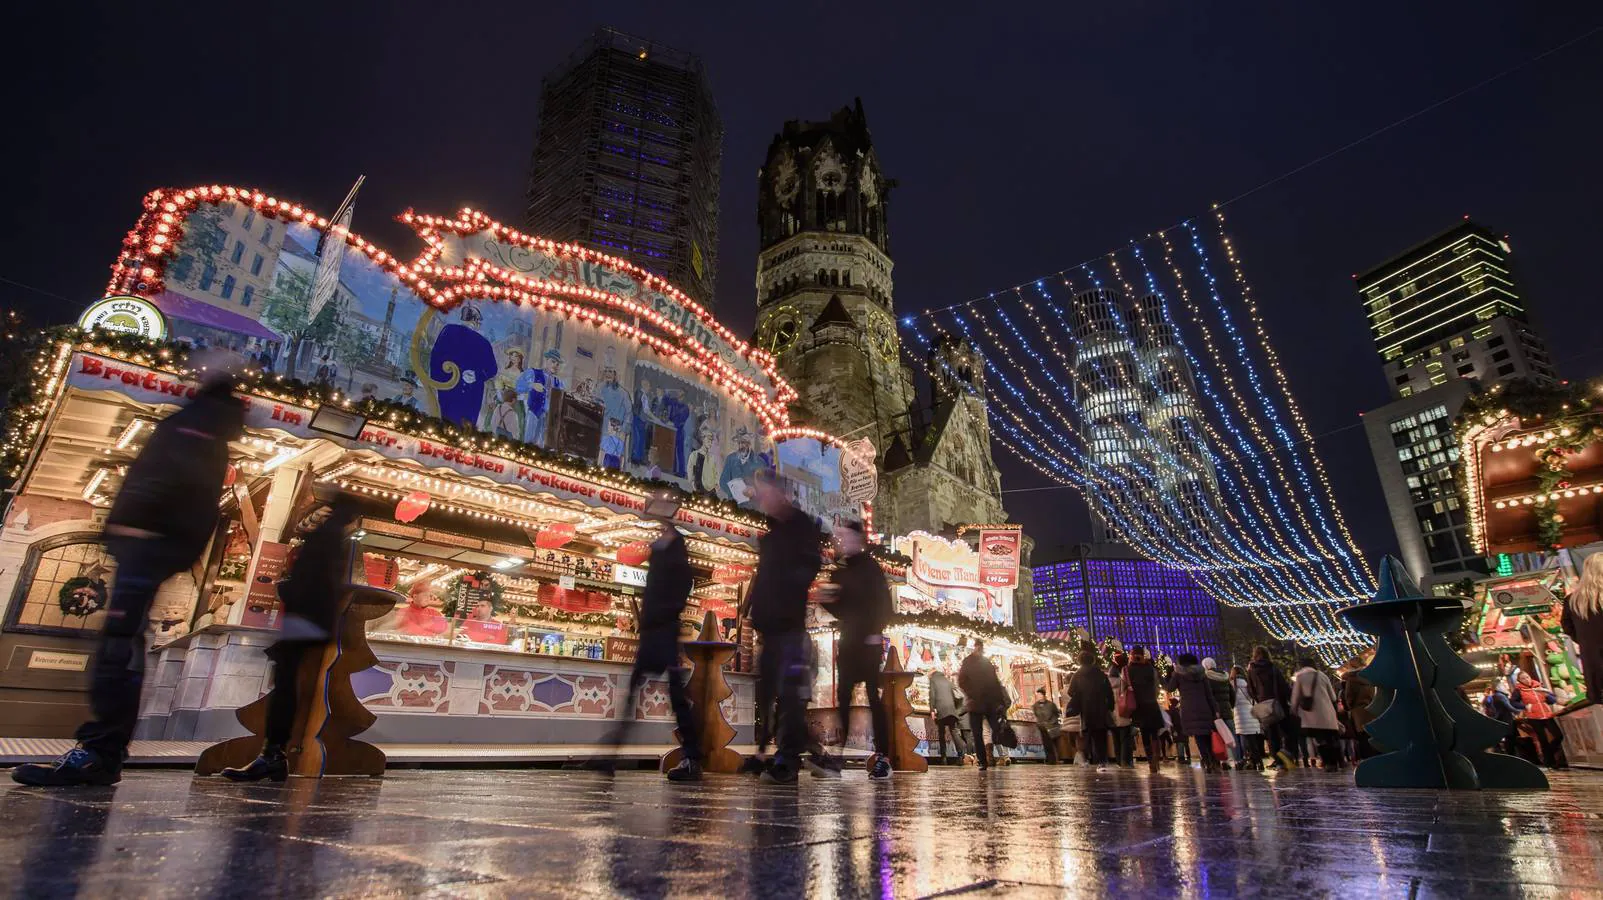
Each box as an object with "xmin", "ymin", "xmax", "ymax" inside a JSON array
[{"xmin": 1353, "ymin": 218, "xmax": 1557, "ymax": 398}]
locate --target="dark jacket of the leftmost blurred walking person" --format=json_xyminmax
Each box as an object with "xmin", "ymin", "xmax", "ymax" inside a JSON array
[{"xmin": 106, "ymin": 379, "xmax": 245, "ymax": 561}]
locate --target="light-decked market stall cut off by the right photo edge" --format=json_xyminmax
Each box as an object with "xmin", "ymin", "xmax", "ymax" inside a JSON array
[{"xmin": 1457, "ymin": 375, "xmax": 1603, "ymax": 765}]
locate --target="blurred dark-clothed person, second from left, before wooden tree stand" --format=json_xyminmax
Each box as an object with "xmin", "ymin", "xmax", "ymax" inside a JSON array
[{"xmin": 223, "ymin": 493, "xmax": 361, "ymax": 781}]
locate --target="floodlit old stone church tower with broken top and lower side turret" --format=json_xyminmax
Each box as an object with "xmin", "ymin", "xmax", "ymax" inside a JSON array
[{"xmin": 753, "ymin": 99, "xmax": 1007, "ymax": 534}]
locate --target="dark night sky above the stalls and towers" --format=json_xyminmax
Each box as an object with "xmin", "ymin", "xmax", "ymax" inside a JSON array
[{"xmin": 0, "ymin": 0, "xmax": 1603, "ymax": 555}]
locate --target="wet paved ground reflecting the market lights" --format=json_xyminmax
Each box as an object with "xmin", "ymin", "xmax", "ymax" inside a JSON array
[{"xmin": 0, "ymin": 765, "xmax": 1603, "ymax": 900}]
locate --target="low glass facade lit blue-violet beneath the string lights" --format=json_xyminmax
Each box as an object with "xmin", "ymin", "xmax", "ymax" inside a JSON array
[{"xmin": 1032, "ymin": 558, "xmax": 1223, "ymax": 658}]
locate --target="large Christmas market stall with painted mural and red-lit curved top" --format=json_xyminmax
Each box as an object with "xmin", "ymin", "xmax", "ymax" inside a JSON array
[{"xmin": 0, "ymin": 186, "xmax": 851, "ymax": 743}]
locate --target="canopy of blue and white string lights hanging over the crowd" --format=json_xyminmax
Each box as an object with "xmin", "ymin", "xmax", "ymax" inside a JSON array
[{"xmin": 902, "ymin": 209, "xmax": 1375, "ymax": 664}]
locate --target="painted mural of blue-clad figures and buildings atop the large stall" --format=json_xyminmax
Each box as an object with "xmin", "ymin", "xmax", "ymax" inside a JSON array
[{"xmin": 157, "ymin": 202, "xmax": 774, "ymax": 504}]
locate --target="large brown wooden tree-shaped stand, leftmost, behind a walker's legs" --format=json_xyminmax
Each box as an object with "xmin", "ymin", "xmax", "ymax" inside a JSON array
[{"xmin": 196, "ymin": 584, "xmax": 401, "ymax": 778}]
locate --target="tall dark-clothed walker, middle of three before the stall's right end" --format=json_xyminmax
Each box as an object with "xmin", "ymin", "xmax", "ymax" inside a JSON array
[{"xmin": 750, "ymin": 468, "xmax": 824, "ymax": 784}]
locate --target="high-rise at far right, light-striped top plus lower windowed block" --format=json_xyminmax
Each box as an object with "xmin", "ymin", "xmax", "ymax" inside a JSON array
[{"xmin": 1353, "ymin": 218, "xmax": 1557, "ymax": 589}]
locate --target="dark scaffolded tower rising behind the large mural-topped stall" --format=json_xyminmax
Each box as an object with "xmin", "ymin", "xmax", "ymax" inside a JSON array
[{"xmin": 526, "ymin": 27, "xmax": 723, "ymax": 306}]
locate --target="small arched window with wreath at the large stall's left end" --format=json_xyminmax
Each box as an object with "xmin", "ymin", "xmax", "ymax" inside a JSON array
[{"xmin": 6, "ymin": 531, "xmax": 117, "ymax": 637}]
